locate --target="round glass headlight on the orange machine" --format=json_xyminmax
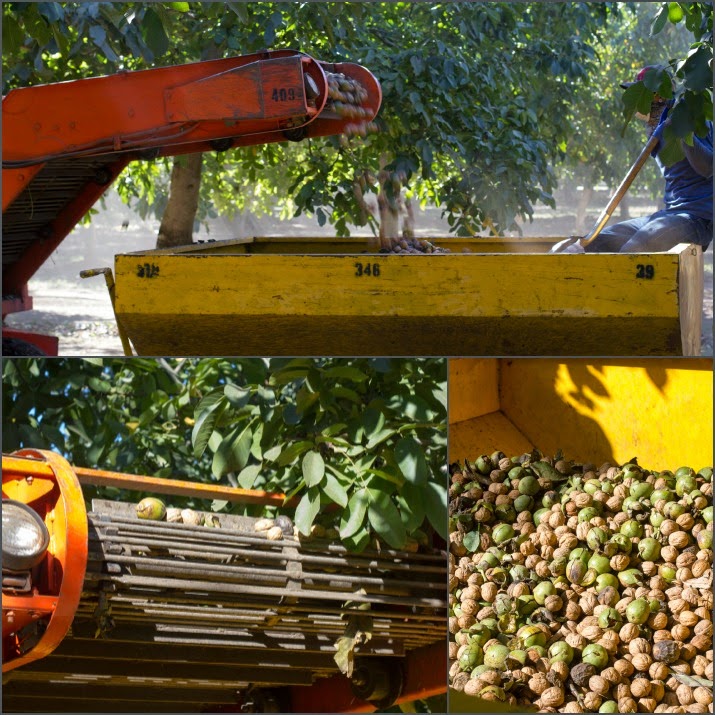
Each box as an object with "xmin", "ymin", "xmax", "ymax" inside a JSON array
[{"xmin": 2, "ymin": 499, "xmax": 50, "ymax": 571}]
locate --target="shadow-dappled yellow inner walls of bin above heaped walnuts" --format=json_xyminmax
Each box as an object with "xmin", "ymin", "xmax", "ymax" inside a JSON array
[{"xmin": 450, "ymin": 359, "xmax": 713, "ymax": 470}]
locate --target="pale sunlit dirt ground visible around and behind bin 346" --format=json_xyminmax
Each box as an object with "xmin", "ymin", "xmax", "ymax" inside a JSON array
[{"xmin": 7, "ymin": 194, "xmax": 713, "ymax": 356}]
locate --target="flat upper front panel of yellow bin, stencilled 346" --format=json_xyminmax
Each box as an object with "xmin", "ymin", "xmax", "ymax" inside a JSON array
[{"xmin": 116, "ymin": 254, "xmax": 678, "ymax": 318}]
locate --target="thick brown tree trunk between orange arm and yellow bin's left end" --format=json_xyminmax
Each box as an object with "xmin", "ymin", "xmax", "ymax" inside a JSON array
[{"xmin": 156, "ymin": 153, "xmax": 203, "ymax": 248}]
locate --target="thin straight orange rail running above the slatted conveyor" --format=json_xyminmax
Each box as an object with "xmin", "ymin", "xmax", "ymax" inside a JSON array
[{"xmin": 2, "ymin": 454, "xmax": 298, "ymax": 506}]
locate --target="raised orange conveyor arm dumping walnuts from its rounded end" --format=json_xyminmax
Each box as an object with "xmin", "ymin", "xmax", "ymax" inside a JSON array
[{"xmin": 2, "ymin": 50, "xmax": 381, "ymax": 324}]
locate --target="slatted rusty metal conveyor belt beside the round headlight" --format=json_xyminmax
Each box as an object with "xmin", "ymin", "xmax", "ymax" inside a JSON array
[{"xmin": 3, "ymin": 500, "xmax": 447, "ymax": 712}]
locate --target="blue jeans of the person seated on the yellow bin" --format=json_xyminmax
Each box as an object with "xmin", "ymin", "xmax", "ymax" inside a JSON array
[{"xmin": 586, "ymin": 211, "xmax": 713, "ymax": 253}]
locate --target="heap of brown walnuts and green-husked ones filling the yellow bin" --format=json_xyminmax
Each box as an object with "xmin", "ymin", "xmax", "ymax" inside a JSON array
[{"xmin": 449, "ymin": 450, "xmax": 713, "ymax": 712}]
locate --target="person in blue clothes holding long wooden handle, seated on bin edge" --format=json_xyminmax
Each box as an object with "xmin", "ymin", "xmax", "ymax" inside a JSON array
[{"xmin": 565, "ymin": 67, "xmax": 713, "ymax": 253}]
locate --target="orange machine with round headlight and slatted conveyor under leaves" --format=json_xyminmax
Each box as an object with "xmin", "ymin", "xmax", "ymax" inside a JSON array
[{"xmin": 2, "ymin": 449, "xmax": 447, "ymax": 712}]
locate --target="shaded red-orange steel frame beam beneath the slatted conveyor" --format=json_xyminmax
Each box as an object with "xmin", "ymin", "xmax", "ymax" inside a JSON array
[{"xmin": 291, "ymin": 640, "xmax": 448, "ymax": 713}]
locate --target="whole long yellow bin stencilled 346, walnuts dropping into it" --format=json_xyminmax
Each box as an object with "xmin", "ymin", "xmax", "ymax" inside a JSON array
[{"xmin": 110, "ymin": 238, "xmax": 703, "ymax": 356}]
